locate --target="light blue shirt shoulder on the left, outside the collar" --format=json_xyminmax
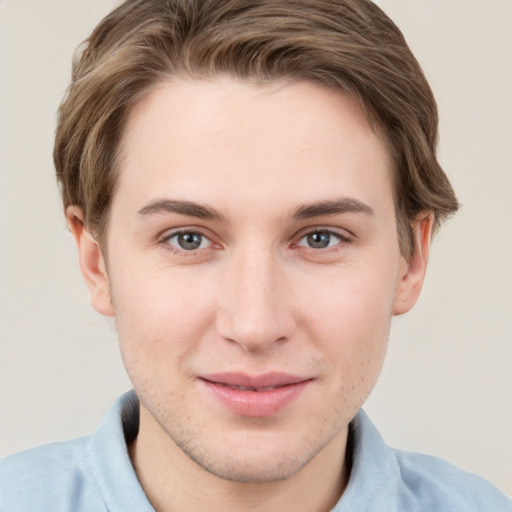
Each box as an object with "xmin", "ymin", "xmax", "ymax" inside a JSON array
[{"xmin": 0, "ymin": 438, "xmax": 105, "ymax": 512}]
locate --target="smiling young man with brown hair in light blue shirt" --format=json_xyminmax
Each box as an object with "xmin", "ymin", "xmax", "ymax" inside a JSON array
[{"xmin": 0, "ymin": 0, "xmax": 512, "ymax": 511}]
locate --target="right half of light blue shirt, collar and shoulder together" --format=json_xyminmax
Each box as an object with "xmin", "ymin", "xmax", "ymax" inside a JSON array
[{"xmin": 335, "ymin": 411, "xmax": 512, "ymax": 512}]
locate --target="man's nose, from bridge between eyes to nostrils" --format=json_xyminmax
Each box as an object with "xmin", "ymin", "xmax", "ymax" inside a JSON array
[{"xmin": 217, "ymin": 247, "xmax": 296, "ymax": 352}]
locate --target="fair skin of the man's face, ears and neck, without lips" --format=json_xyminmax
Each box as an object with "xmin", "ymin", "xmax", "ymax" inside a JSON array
[{"xmin": 67, "ymin": 78, "xmax": 432, "ymax": 511}]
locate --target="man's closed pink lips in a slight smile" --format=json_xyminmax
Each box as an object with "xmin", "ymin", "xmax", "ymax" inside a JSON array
[{"xmin": 199, "ymin": 373, "xmax": 313, "ymax": 417}]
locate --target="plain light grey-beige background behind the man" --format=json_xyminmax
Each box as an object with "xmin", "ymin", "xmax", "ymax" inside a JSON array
[{"xmin": 0, "ymin": 0, "xmax": 512, "ymax": 495}]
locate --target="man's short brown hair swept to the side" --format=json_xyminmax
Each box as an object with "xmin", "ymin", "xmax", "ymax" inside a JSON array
[{"xmin": 54, "ymin": 0, "xmax": 458, "ymax": 256}]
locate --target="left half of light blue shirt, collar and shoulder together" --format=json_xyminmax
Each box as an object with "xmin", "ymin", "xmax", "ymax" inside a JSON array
[{"xmin": 0, "ymin": 392, "xmax": 148, "ymax": 512}]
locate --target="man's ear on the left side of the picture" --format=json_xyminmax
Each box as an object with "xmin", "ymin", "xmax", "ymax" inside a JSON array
[{"xmin": 66, "ymin": 206, "xmax": 114, "ymax": 316}]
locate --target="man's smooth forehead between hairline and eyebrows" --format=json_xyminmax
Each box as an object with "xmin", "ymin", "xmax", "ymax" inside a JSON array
[{"xmin": 114, "ymin": 78, "xmax": 392, "ymax": 219}]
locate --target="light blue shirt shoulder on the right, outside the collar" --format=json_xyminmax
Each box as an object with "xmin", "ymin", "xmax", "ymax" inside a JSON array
[{"xmin": 392, "ymin": 450, "xmax": 512, "ymax": 512}]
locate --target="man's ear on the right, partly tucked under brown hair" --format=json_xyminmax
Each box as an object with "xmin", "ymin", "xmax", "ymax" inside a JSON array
[{"xmin": 393, "ymin": 212, "xmax": 434, "ymax": 316}]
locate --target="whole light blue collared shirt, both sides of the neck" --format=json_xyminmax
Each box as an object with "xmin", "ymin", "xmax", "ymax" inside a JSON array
[{"xmin": 0, "ymin": 392, "xmax": 512, "ymax": 512}]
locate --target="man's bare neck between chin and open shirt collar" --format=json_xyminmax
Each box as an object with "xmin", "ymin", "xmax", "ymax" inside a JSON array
[{"xmin": 130, "ymin": 406, "xmax": 350, "ymax": 512}]
